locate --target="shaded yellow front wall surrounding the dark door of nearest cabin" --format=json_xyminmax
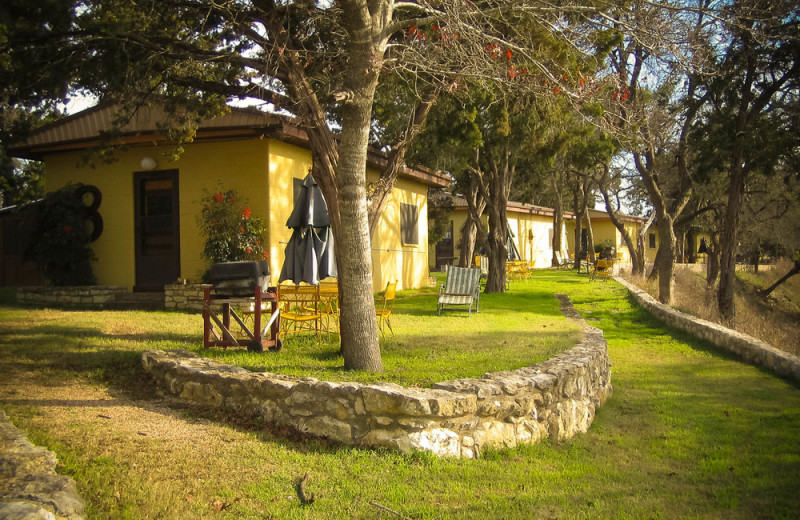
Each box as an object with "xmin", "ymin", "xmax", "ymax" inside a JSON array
[{"xmin": 45, "ymin": 140, "xmax": 267, "ymax": 288}]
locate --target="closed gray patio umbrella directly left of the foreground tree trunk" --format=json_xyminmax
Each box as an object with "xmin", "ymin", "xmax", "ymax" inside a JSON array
[{"xmin": 278, "ymin": 174, "xmax": 337, "ymax": 285}]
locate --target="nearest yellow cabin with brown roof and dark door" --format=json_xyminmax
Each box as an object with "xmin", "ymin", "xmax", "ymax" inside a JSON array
[{"xmin": 3, "ymin": 105, "xmax": 449, "ymax": 292}]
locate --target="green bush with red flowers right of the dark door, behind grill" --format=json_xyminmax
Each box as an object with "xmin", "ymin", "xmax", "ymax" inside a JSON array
[{"xmin": 197, "ymin": 186, "xmax": 265, "ymax": 264}]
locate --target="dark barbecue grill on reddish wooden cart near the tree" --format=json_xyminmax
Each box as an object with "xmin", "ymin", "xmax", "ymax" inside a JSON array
[{"xmin": 203, "ymin": 261, "xmax": 281, "ymax": 352}]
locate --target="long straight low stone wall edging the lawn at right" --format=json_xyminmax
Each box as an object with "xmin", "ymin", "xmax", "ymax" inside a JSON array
[{"xmin": 615, "ymin": 278, "xmax": 800, "ymax": 382}]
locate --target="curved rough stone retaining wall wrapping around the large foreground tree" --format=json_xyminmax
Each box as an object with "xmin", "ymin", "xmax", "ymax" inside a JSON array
[{"xmin": 142, "ymin": 294, "xmax": 611, "ymax": 458}]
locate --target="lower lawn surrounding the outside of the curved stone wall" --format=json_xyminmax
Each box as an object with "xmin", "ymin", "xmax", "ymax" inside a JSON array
[{"xmin": 0, "ymin": 271, "xmax": 800, "ymax": 519}]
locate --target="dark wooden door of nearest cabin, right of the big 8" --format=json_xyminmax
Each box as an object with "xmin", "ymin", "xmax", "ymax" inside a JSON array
[{"xmin": 133, "ymin": 170, "xmax": 181, "ymax": 291}]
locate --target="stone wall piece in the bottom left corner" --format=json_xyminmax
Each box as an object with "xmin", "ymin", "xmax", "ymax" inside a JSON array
[{"xmin": 0, "ymin": 410, "xmax": 86, "ymax": 520}]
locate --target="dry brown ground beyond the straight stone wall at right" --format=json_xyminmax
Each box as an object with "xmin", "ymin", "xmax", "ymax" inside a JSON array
[{"xmin": 628, "ymin": 261, "xmax": 800, "ymax": 356}]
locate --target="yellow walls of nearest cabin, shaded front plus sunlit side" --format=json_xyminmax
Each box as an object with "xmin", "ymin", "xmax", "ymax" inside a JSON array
[{"xmin": 46, "ymin": 139, "xmax": 429, "ymax": 292}]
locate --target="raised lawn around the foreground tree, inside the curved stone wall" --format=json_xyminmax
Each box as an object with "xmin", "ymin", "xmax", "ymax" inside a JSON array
[{"xmin": 197, "ymin": 278, "xmax": 580, "ymax": 386}]
